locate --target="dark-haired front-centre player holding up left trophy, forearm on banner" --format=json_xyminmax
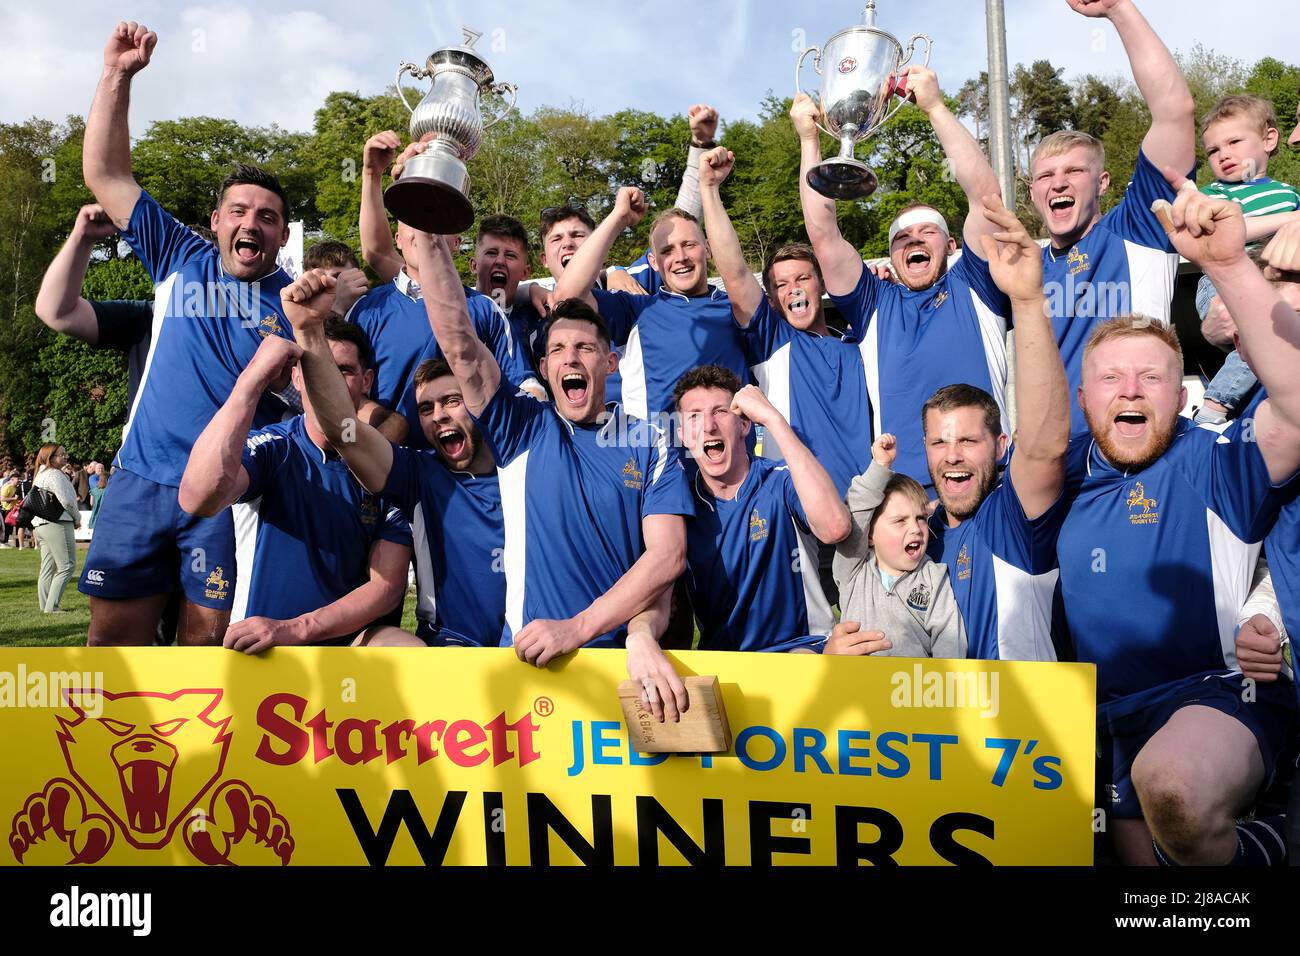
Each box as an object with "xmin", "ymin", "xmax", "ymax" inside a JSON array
[{"xmin": 397, "ymin": 223, "xmax": 692, "ymax": 717}]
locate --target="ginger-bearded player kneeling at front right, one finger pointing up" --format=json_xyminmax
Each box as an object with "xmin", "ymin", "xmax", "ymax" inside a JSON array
[{"xmin": 1058, "ymin": 179, "xmax": 1300, "ymax": 865}]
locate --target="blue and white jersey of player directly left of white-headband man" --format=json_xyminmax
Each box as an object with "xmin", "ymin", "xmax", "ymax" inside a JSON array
[{"xmin": 741, "ymin": 295, "xmax": 873, "ymax": 496}]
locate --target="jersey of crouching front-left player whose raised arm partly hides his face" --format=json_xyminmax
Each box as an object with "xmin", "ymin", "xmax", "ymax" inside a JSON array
[{"xmin": 230, "ymin": 415, "xmax": 411, "ymax": 622}]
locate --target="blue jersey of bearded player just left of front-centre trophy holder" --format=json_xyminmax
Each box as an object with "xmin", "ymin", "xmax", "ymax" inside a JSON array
[{"xmin": 384, "ymin": 445, "xmax": 506, "ymax": 648}]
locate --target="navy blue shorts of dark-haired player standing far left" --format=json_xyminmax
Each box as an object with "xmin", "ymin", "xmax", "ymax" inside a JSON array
[{"xmin": 77, "ymin": 468, "xmax": 235, "ymax": 611}]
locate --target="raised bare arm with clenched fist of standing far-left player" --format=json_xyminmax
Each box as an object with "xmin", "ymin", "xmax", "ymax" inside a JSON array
[{"xmin": 82, "ymin": 21, "xmax": 159, "ymax": 229}]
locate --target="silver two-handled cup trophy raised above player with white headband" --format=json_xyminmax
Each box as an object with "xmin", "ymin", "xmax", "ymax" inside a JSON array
[{"xmin": 794, "ymin": 0, "xmax": 931, "ymax": 199}]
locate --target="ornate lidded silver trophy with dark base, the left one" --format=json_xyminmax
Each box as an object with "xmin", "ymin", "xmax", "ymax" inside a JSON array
[{"xmin": 384, "ymin": 29, "xmax": 519, "ymax": 235}]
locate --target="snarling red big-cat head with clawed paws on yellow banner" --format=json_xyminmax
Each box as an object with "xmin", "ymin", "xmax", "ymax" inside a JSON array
[{"xmin": 9, "ymin": 688, "xmax": 294, "ymax": 866}]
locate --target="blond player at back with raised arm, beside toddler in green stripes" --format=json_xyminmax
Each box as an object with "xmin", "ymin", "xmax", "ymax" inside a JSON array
[{"xmin": 1030, "ymin": 0, "xmax": 1196, "ymax": 434}]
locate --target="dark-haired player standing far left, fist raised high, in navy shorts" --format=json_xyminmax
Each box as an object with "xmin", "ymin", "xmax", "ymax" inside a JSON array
[{"xmin": 78, "ymin": 22, "xmax": 293, "ymax": 645}]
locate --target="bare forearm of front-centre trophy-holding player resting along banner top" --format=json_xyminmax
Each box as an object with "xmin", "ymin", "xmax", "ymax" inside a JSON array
[{"xmin": 515, "ymin": 515, "xmax": 686, "ymax": 667}]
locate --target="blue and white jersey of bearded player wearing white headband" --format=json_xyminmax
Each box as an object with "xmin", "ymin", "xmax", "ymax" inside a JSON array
[{"xmin": 831, "ymin": 247, "xmax": 1011, "ymax": 498}]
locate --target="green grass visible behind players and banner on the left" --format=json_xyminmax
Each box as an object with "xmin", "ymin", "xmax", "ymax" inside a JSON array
[{"xmin": 0, "ymin": 545, "xmax": 415, "ymax": 648}]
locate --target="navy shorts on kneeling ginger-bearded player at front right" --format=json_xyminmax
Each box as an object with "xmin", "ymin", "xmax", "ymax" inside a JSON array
[{"xmin": 1097, "ymin": 674, "xmax": 1296, "ymax": 819}]
